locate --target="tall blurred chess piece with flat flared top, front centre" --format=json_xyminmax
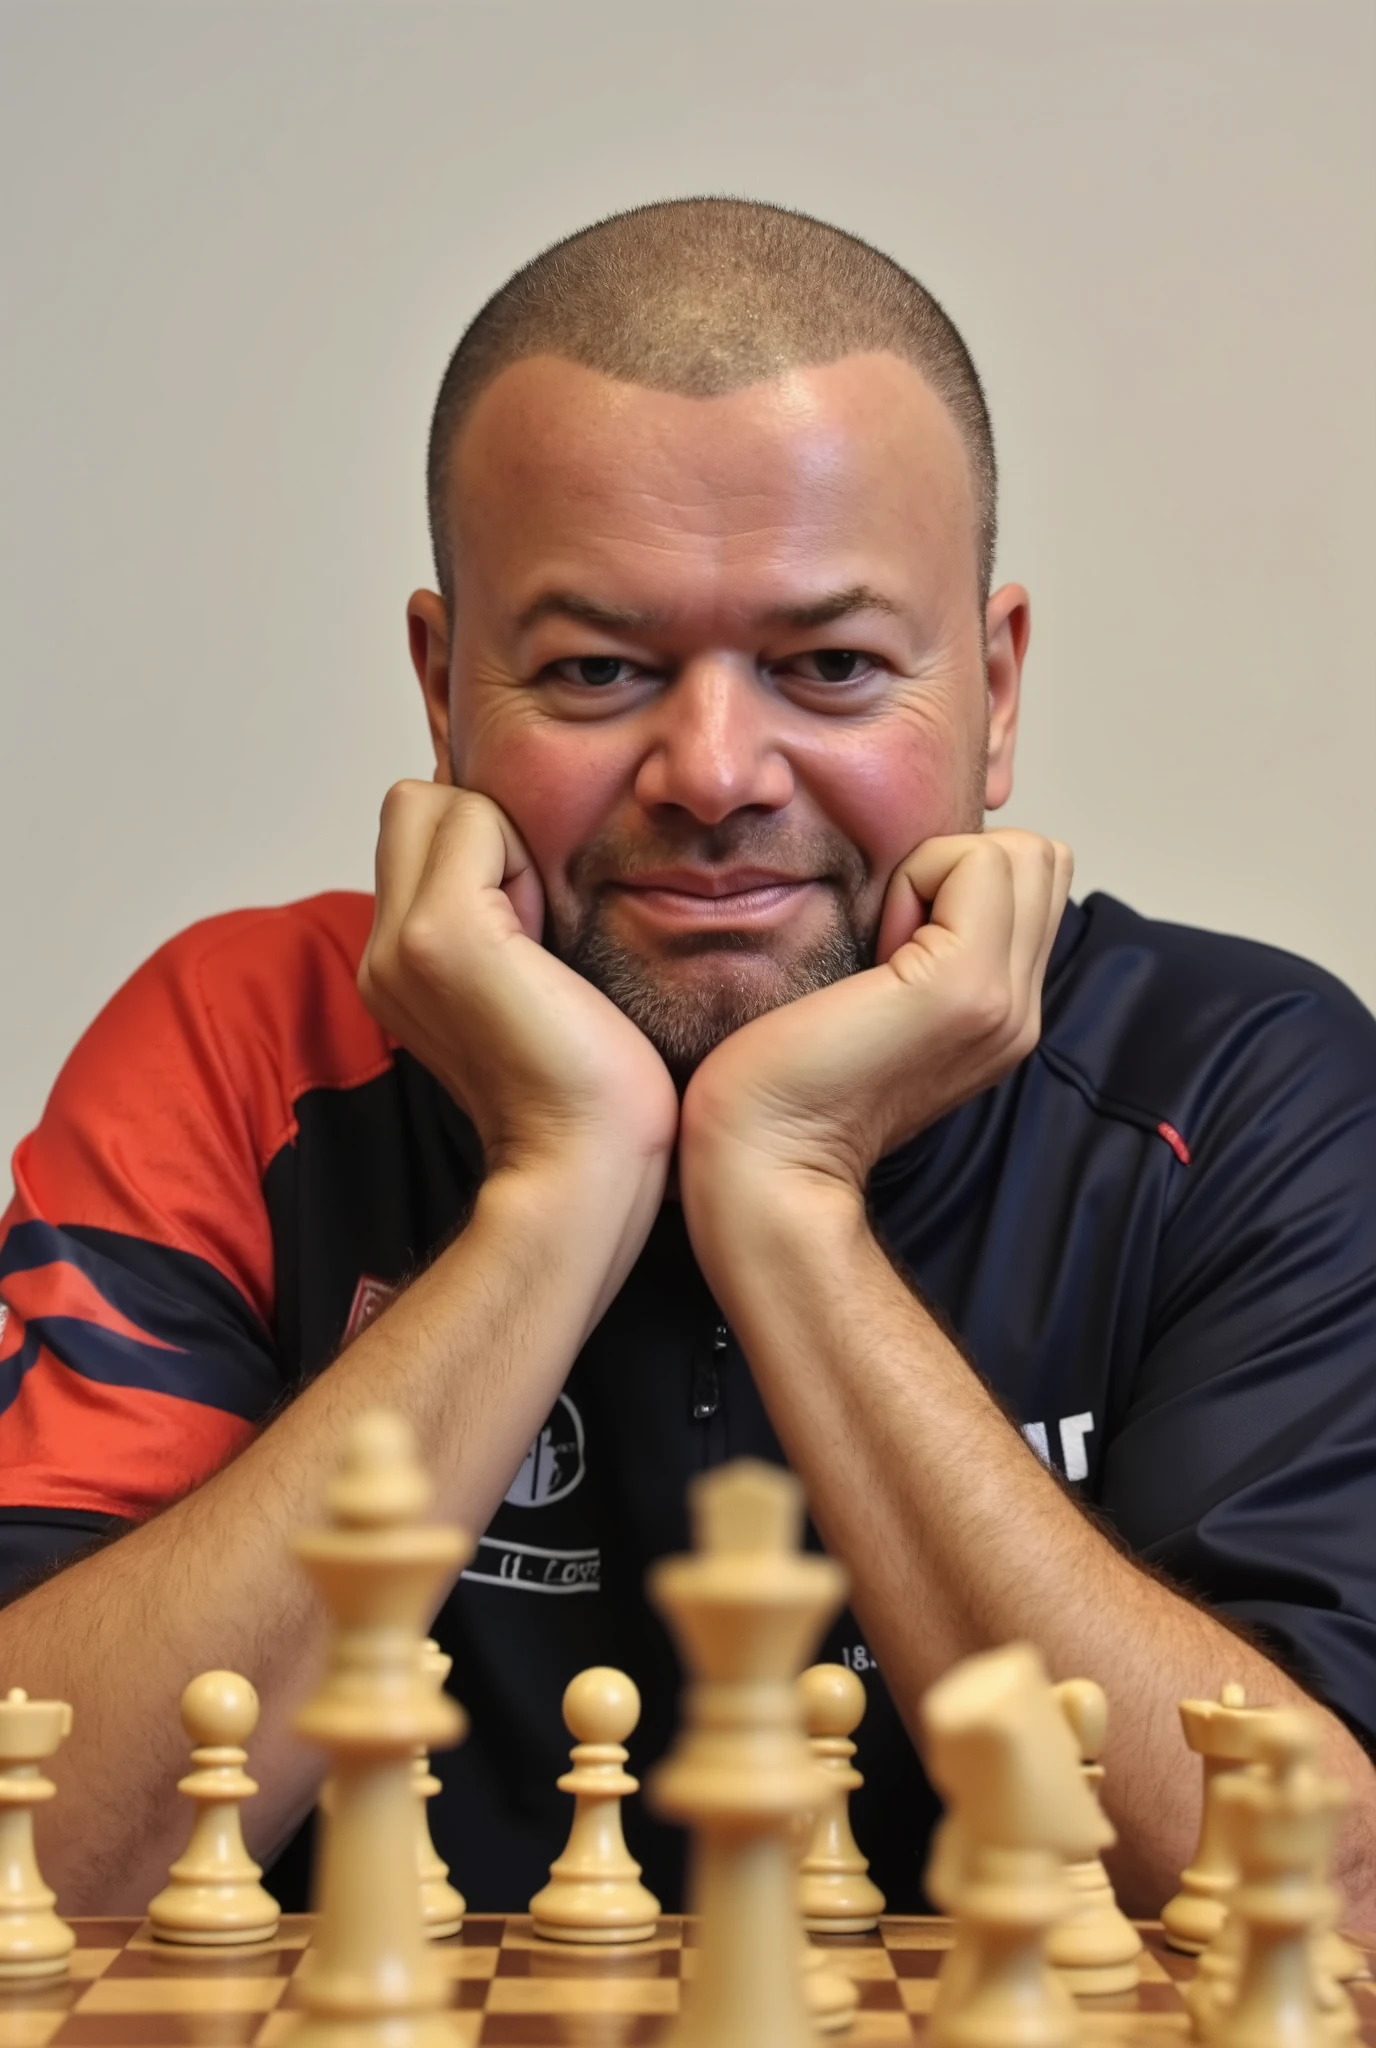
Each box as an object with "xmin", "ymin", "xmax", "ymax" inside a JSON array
[{"xmin": 647, "ymin": 1458, "xmax": 846, "ymax": 2048}]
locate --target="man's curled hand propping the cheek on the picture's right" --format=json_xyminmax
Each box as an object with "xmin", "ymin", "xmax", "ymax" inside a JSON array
[{"xmin": 680, "ymin": 831, "xmax": 1071, "ymax": 1228}]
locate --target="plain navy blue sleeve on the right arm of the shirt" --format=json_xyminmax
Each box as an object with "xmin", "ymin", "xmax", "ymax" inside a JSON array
[{"xmin": 1102, "ymin": 971, "xmax": 1376, "ymax": 1749}]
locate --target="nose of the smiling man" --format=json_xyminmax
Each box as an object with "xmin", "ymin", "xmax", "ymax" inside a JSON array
[{"xmin": 635, "ymin": 655, "xmax": 792, "ymax": 825}]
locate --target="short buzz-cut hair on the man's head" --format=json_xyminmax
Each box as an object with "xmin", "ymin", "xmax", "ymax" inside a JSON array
[{"xmin": 426, "ymin": 199, "xmax": 997, "ymax": 623}]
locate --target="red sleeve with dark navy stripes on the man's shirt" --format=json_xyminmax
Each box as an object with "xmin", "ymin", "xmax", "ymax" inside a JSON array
[{"xmin": 0, "ymin": 895, "xmax": 391, "ymax": 1520}]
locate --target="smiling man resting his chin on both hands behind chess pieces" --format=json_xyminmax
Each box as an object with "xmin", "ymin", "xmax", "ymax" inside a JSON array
[{"xmin": 0, "ymin": 201, "xmax": 1376, "ymax": 1911}]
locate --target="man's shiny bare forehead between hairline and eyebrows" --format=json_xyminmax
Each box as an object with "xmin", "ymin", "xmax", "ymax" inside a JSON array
[{"xmin": 448, "ymin": 354, "xmax": 979, "ymax": 639}]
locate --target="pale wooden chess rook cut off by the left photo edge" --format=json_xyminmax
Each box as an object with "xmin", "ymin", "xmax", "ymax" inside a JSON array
[{"xmin": 0, "ymin": 1686, "xmax": 76, "ymax": 1985}]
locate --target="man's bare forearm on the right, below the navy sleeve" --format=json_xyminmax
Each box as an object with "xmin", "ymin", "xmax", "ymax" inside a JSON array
[{"xmin": 700, "ymin": 1190, "xmax": 1376, "ymax": 1925}]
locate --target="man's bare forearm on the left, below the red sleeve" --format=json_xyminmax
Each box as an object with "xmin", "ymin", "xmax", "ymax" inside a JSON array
[{"xmin": 0, "ymin": 1174, "xmax": 637, "ymax": 1913}]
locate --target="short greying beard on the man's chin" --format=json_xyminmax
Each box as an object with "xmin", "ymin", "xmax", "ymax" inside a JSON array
[{"xmin": 547, "ymin": 905, "xmax": 878, "ymax": 1094}]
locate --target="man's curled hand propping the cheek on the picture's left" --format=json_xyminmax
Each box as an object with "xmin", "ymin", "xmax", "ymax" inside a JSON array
[{"xmin": 358, "ymin": 782, "xmax": 678, "ymax": 1196}]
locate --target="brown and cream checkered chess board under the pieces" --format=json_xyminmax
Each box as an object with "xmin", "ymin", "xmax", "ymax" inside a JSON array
[{"xmin": 0, "ymin": 1915, "xmax": 1376, "ymax": 2048}]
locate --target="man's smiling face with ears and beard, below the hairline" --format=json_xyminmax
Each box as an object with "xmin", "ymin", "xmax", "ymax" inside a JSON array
[{"xmin": 412, "ymin": 354, "xmax": 1026, "ymax": 1077}]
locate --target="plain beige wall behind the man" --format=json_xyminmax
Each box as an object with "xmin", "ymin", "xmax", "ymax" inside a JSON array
[{"xmin": 0, "ymin": 0, "xmax": 1376, "ymax": 1179}]
